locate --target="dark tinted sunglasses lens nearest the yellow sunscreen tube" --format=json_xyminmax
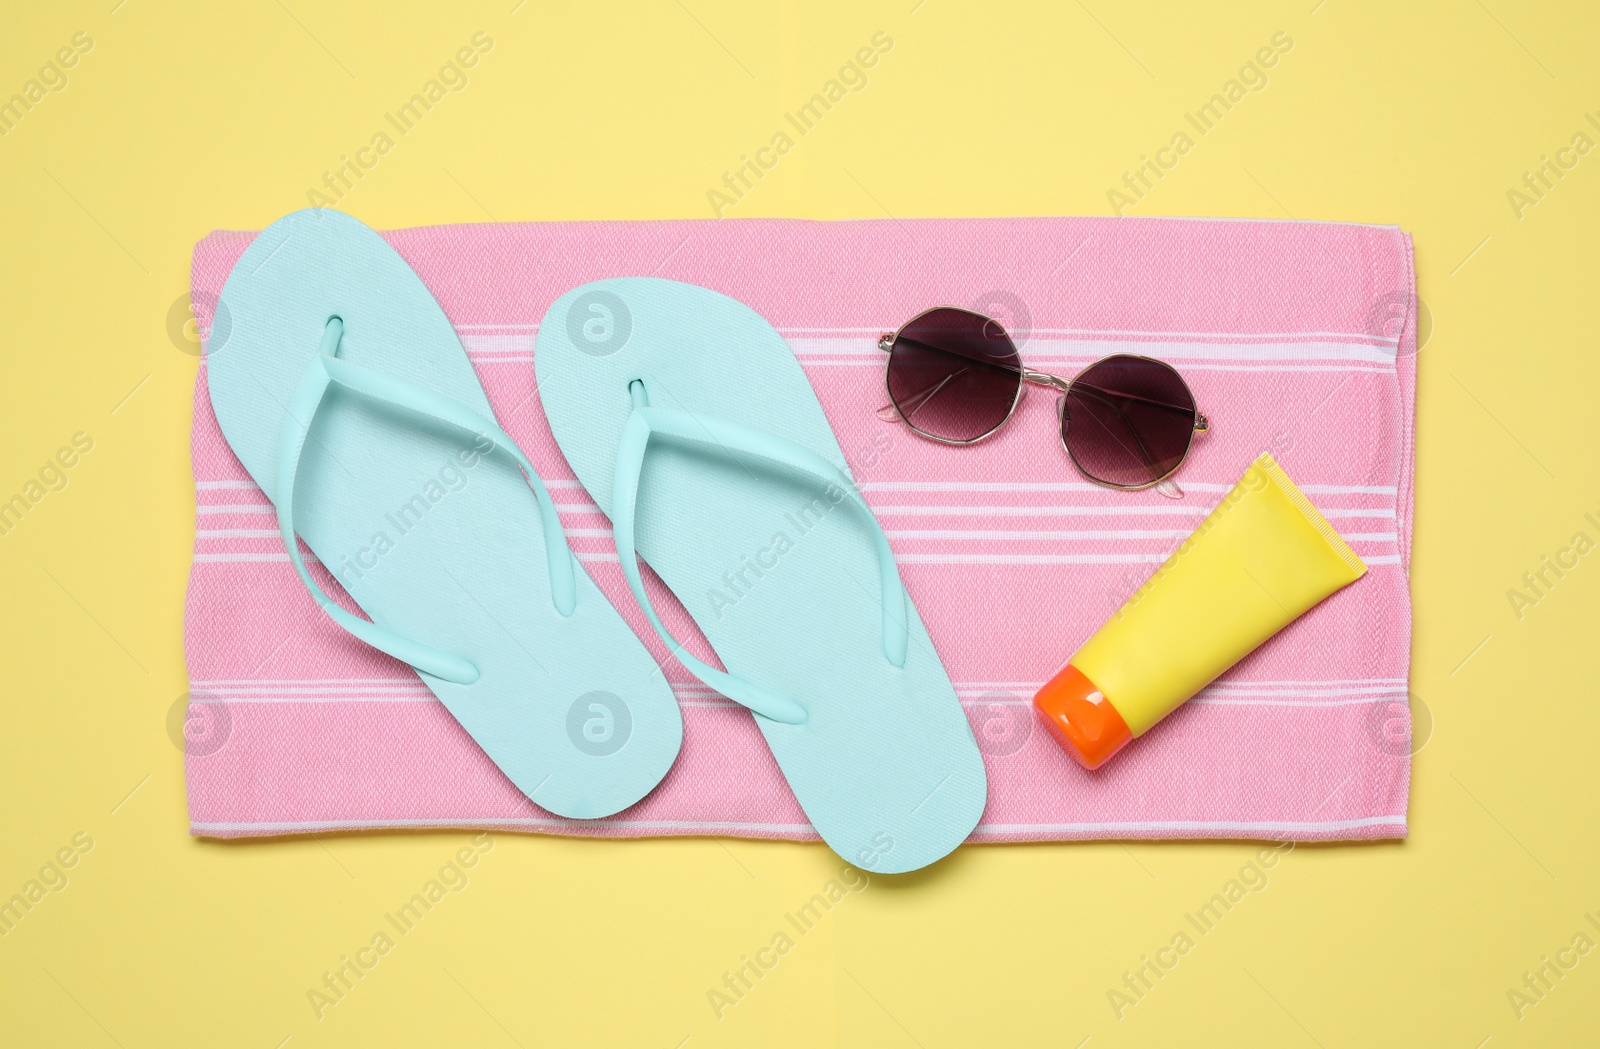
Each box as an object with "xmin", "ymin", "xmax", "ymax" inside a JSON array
[{"xmin": 1061, "ymin": 353, "xmax": 1195, "ymax": 488}]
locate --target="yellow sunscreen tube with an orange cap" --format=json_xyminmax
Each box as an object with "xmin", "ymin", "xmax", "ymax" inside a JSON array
[{"xmin": 1034, "ymin": 454, "xmax": 1366, "ymax": 769}]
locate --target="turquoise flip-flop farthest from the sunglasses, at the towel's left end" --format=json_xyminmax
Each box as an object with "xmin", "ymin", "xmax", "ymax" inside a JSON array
[{"xmin": 206, "ymin": 209, "xmax": 683, "ymax": 819}]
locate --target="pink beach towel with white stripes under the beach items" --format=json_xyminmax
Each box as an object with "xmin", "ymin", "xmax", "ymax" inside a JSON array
[{"xmin": 184, "ymin": 212, "xmax": 1416, "ymax": 841}]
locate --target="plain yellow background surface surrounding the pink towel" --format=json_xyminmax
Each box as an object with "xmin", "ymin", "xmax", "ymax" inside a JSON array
[{"xmin": 0, "ymin": 0, "xmax": 1600, "ymax": 1049}]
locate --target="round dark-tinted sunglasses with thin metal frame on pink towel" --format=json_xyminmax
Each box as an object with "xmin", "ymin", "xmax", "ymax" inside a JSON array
[{"xmin": 878, "ymin": 305, "xmax": 1210, "ymax": 497}]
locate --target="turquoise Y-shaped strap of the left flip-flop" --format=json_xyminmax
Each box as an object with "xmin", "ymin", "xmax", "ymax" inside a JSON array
[{"xmin": 277, "ymin": 318, "xmax": 578, "ymax": 684}]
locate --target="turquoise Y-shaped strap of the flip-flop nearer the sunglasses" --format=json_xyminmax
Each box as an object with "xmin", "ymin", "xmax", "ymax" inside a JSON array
[{"xmin": 611, "ymin": 379, "xmax": 907, "ymax": 724}]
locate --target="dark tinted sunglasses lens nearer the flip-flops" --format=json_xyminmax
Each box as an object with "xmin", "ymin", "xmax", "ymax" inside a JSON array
[{"xmin": 888, "ymin": 307, "xmax": 1022, "ymax": 441}]
